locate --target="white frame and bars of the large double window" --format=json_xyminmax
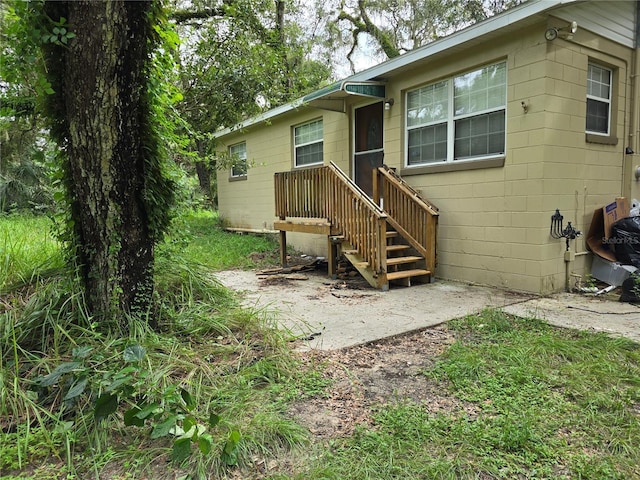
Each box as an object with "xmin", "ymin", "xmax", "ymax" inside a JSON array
[{"xmin": 404, "ymin": 60, "xmax": 507, "ymax": 169}]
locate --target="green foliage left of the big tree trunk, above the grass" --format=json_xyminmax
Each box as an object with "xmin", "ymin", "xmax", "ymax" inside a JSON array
[{"xmin": 0, "ymin": 2, "xmax": 62, "ymax": 216}]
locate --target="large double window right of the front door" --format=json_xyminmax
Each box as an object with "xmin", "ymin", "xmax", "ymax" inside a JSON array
[{"xmin": 407, "ymin": 62, "xmax": 507, "ymax": 166}]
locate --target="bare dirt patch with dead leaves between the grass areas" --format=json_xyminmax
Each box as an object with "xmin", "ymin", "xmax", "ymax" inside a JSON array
[{"xmin": 290, "ymin": 325, "xmax": 476, "ymax": 440}]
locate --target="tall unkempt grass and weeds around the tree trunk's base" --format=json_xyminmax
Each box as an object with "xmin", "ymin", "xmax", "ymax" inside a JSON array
[{"xmin": 0, "ymin": 215, "xmax": 306, "ymax": 478}]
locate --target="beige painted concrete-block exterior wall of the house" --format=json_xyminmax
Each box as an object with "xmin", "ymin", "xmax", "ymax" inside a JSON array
[{"xmin": 218, "ymin": 19, "xmax": 640, "ymax": 293}]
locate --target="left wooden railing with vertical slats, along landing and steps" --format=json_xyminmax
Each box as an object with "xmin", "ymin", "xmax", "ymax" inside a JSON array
[{"xmin": 274, "ymin": 162, "xmax": 387, "ymax": 273}]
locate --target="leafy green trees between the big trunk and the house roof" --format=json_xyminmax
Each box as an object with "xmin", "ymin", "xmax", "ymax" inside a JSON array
[{"xmin": 174, "ymin": 0, "xmax": 331, "ymax": 204}]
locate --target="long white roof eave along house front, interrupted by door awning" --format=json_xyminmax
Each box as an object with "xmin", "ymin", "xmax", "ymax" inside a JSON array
[{"xmin": 213, "ymin": 0, "xmax": 582, "ymax": 138}]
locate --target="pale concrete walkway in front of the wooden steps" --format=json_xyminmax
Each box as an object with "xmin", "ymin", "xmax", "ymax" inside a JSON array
[{"xmin": 216, "ymin": 271, "xmax": 640, "ymax": 350}]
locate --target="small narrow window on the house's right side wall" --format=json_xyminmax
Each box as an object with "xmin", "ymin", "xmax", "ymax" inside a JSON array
[{"xmin": 587, "ymin": 63, "xmax": 612, "ymax": 135}]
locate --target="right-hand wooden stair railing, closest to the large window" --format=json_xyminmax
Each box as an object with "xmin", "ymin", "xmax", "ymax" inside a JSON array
[{"xmin": 373, "ymin": 165, "xmax": 439, "ymax": 272}]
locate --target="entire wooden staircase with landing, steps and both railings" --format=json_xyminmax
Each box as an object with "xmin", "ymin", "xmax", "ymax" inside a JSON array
[{"xmin": 274, "ymin": 163, "xmax": 438, "ymax": 290}]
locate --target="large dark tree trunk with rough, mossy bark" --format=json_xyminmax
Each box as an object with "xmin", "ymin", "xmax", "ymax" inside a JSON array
[{"xmin": 47, "ymin": 0, "xmax": 159, "ymax": 326}]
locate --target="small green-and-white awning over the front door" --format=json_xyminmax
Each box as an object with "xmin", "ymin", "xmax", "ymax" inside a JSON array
[{"xmin": 302, "ymin": 80, "xmax": 386, "ymax": 113}]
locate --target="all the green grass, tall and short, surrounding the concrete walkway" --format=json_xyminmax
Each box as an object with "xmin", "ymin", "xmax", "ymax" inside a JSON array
[{"xmin": 0, "ymin": 213, "xmax": 640, "ymax": 480}]
